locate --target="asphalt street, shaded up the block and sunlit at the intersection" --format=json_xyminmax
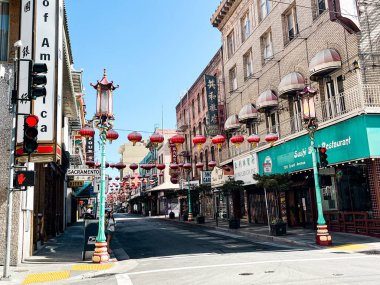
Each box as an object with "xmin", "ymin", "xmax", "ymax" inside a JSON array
[{"xmin": 68, "ymin": 214, "xmax": 380, "ymax": 285}]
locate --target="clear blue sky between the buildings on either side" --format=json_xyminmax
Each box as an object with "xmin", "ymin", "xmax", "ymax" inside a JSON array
[{"xmin": 65, "ymin": 0, "xmax": 221, "ymax": 161}]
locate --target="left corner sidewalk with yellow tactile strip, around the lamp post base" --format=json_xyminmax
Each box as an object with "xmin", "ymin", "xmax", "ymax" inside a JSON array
[{"xmin": 0, "ymin": 222, "xmax": 131, "ymax": 285}]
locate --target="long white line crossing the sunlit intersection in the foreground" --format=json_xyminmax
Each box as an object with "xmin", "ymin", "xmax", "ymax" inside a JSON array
[{"xmin": 128, "ymin": 255, "xmax": 378, "ymax": 276}]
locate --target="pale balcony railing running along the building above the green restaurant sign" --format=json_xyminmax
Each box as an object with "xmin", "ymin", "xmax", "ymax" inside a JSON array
[{"xmin": 226, "ymin": 85, "xmax": 380, "ymax": 159}]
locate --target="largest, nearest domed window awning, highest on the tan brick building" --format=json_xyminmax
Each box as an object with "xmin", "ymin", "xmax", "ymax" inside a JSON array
[{"xmin": 309, "ymin": 48, "xmax": 342, "ymax": 76}]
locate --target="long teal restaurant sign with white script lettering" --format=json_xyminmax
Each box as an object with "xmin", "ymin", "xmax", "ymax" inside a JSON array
[{"xmin": 258, "ymin": 115, "xmax": 380, "ymax": 175}]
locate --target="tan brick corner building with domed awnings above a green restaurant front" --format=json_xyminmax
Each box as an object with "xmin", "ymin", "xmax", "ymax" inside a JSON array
[{"xmin": 211, "ymin": 0, "xmax": 380, "ymax": 233}]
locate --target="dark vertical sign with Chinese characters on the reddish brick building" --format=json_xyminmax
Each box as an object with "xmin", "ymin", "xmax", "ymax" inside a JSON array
[{"xmin": 205, "ymin": 75, "xmax": 219, "ymax": 136}]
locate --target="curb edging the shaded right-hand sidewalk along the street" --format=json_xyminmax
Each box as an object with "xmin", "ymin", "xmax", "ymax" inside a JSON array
[{"xmin": 159, "ymin": 218, "xmax": 324, "ymax": 249}]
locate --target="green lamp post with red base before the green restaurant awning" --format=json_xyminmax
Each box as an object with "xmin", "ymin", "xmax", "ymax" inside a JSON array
[{"xmin": 299, "ymin": 86, "xmax": 332, "ymax": 245}]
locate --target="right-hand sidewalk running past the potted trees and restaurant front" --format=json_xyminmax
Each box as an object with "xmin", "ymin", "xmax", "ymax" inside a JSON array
[{"xmin": 159, "ymin": 216, "xmax": 380, "ymax": 253}]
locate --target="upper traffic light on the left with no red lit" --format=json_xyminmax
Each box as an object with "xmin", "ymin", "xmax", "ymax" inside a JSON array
[{"xmin": 29, "ymin": 63, "xmax": 47, "ymax": 100}]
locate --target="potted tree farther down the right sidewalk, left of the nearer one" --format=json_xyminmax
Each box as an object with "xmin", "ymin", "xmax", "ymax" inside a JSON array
[{"xmin": 221, "ymin": 180, "xmax": 244, "ymax": 229}]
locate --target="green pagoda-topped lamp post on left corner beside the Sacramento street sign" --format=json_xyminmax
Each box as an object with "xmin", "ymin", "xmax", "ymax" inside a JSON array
[{"xmin": 80, "ymin": 69, "xmax": 119, "ymax": 263}]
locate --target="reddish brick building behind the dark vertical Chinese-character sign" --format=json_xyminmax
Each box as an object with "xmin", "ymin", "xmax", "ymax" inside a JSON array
[{"xmin": 176, "ymin": 48, "xmax": 227, "ymax": 217}]
